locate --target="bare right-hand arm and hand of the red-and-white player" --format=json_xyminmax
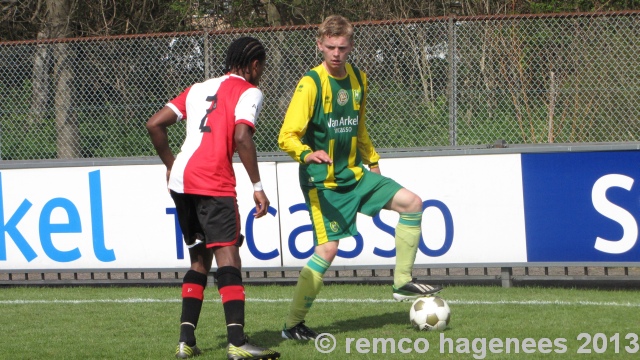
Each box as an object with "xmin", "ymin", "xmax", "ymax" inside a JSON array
[{"xmin": 233, "ymin": 124, "xmax": 269, "ymax": 218}]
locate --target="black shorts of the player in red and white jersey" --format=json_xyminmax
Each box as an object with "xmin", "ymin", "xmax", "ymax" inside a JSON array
[{"xmin": 171, "ymin": 191, "xmax": 244, "ymax": 248}]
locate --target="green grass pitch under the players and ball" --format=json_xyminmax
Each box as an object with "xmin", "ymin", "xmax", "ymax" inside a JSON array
[{"xmin": 0, "ymin": 285, "xmax": 640, "ymax": 359}]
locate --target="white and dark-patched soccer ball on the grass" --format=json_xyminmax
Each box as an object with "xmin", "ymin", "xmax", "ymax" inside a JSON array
[{"xmin": 409, "ymin": 296, "xmax": 451, "ymax": 331}]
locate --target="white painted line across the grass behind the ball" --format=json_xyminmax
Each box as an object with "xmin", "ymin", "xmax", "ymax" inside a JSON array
[{"xmin": 0, "ymin": 298, "xmax": 640, "ymax": 308}]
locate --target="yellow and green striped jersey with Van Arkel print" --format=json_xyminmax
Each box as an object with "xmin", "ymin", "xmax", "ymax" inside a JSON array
[{"xmin": 278, "ymin": 64, "xmax": 380, "ymax": 189}]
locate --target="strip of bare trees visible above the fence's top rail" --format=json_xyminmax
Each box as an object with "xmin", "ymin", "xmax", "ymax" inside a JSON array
[{"xmin": 0, "ymin": 0, "xmax": 640, "ymax": 41}]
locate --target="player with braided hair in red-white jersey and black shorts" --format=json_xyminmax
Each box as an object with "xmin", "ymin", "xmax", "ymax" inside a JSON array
[{"xmin": 147, "ymin": 37, "xmax": 280, "ymax": 359}]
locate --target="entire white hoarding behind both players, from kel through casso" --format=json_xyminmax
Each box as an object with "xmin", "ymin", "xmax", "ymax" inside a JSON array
[{"xmin": 0, "ymin": 155, "xmax": 526, "ymax": 271}]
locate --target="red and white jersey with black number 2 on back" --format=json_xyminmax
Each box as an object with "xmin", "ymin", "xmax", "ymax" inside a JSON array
[{"xmin": 167, "ymin": 74, "xmax": 263, "ymax": 196}]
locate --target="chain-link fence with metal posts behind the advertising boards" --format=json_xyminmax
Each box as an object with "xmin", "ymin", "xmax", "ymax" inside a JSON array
[{"xmin": 0, "ymin": 11, "xmax": 640, "ymax": 160}]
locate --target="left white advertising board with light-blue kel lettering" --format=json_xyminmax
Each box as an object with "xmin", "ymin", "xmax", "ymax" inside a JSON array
[{"xmin": 0, "ymin": 163, "xmax": 280, "ymax": 270}]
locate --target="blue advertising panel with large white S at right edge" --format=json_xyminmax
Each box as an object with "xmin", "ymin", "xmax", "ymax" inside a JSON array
[{"xmin": 522, "ymin": 151, "xmax": 640, "ymax": 262}]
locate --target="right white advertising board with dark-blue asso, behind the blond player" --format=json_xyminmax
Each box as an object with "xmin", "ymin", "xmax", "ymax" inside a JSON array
[{"xmin": 278, "ymin": 155, "xmax": 526, "ymax": 266}]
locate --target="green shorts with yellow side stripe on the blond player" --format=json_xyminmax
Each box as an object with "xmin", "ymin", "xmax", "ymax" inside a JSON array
[{"xmin": 302, "ymin": 171, "xmax": 402, "ymax": 245}]
